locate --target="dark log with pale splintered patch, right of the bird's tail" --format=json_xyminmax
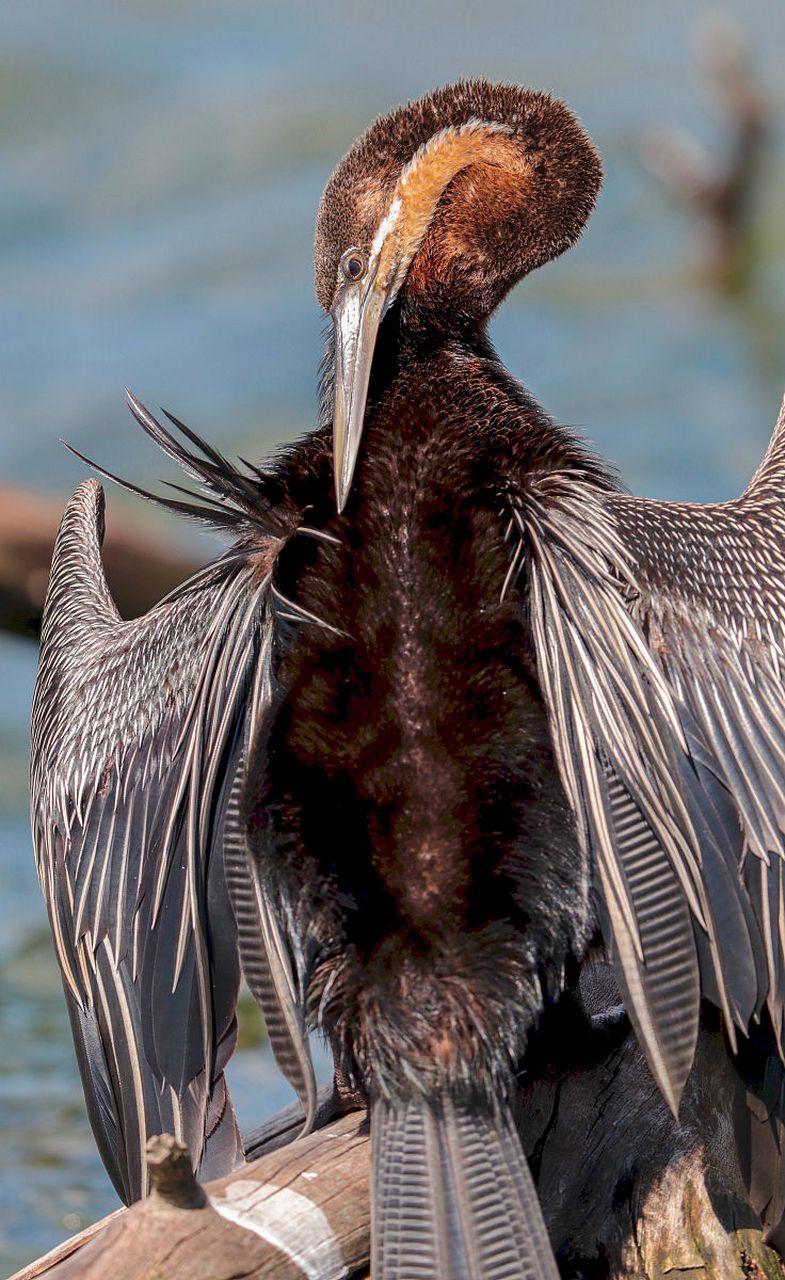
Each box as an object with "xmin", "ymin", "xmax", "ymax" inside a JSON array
[{"xmin": 520, "ymin": 1013, "xmax": 785, "ymax": 1280}]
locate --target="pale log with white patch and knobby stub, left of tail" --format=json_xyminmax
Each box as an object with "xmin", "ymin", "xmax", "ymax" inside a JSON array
[{"xmin": 14, "ymin": 1112, "xmax": 370, "ymax": 1280}]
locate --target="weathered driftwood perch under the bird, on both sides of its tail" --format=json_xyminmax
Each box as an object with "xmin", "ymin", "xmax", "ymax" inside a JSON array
[{"xmin": 14, "ymin": 983, "xmax": 785, "ymax": 1280}]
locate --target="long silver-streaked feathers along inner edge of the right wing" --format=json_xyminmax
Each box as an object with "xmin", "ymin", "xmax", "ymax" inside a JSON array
[{"xmin": 514, "ymin": 474, "xmax": 706, "ymax": 1110}]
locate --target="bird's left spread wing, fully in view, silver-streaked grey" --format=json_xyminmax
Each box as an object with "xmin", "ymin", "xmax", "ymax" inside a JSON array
[{"xmin": 31, "ymin": 401, "xmax": 314, "ymax": 1202}]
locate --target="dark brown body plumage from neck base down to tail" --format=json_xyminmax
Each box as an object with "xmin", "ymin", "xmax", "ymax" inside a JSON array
[{"xmin": 246, "ymin": 363, "xmax": 603, "ymax": 1102}]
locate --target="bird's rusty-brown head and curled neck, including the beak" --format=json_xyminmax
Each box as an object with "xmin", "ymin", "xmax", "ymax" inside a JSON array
[{"xmin": 315, "ymin": 81, "xmax": 602, "ymax": 511}]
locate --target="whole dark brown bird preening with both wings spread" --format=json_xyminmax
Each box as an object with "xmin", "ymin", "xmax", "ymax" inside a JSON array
[{"xmin": 31, "ymin": 81, "xmax": 785, "ymax": 1280}]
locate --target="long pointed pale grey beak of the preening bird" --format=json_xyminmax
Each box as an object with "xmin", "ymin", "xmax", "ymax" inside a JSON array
[{"xmin": 332, "ymin": 279, "xmax": 387, "ymax": 511}]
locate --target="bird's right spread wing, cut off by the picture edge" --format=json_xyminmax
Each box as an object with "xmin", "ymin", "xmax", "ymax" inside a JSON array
[{"xmin": 512, "ymin": 391, "xmax": 785, "ymax": 1110}]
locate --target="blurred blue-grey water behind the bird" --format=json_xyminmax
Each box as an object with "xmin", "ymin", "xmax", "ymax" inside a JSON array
[{"xmin": 0, "ymin": 0, "xmax": 785, "ymax": 1274}]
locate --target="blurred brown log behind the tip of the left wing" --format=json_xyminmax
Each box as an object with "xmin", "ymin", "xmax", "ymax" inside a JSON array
[{"xmin": 0, "ymin": 485, "xmax": 197, "ymax": 637}]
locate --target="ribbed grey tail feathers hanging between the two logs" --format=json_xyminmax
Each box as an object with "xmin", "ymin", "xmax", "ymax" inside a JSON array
[{"xmin": 371, "ymin": 1097, "xmax": 558, "ymax": 1280}]
